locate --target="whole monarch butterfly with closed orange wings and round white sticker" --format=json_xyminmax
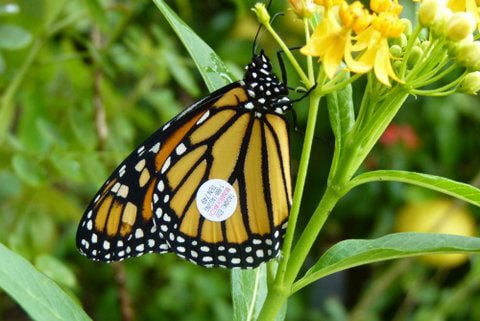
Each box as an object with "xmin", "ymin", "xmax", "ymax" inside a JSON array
[{"xmin": 76, "ymin": 51, "xmax": 292, "ymax": 268}]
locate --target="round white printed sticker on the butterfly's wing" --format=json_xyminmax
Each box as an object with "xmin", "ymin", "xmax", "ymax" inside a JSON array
[{"xmin": 197, "ymin": 178, "xmax": 237, "ymax": 222}]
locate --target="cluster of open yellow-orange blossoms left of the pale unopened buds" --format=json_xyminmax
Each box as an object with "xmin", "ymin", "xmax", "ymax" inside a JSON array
[{"xmin": 300, "ymin": 0, "xmax": 405, "ymax": 86}]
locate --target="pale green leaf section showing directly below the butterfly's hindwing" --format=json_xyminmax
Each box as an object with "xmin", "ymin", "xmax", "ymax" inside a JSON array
[{"xmin": 231, "ymin": 264, "xmax": 268, "ymax": 321}]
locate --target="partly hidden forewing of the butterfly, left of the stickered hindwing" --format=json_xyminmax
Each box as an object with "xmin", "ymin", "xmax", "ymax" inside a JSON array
[{"xmin": 76, "ymin": 83, "xmax": 244, "ymax": 262}]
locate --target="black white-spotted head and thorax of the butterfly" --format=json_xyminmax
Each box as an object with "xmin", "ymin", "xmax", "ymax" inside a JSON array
[{"xmin": 243, "ymin": 50, "xmax": 292, "ymax": 114}]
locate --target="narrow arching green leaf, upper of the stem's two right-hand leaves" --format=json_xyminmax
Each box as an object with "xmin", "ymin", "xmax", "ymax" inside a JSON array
[{"xmin": 348, "ymin": 170, "xmax": 480, "ymax": 206}]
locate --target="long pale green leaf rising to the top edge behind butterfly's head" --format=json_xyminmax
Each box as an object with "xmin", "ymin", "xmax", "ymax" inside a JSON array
[{"xmin": 153, "ymin": 0, "xmax": 233, "ymax": 91}]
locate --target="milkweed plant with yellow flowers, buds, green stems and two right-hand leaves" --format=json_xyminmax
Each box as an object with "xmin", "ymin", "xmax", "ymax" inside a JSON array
[{"xmin": 248, "ymin": 0, "xmax": 480, "ymax": 321}]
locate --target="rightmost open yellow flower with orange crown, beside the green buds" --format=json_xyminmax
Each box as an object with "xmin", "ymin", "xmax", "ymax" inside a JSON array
[{"xmin": 345, "ymin": 11, "xmax": 405, "ymax": 86}]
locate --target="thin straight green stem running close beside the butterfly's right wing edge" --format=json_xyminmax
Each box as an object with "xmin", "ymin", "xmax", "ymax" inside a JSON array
[{"xmin": 278, "ymin": 94, "xmax": 321, "ymax": 282}]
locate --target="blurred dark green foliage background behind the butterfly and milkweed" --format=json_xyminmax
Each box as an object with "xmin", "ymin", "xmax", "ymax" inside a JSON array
[{"xmin": 0, "ymin": 0, "xmax": 480, "ymax": 321}]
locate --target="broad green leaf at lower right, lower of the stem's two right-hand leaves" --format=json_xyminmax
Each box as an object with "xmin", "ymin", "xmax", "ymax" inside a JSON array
[{"xmin": 293, "ymin": 232, "xmax": 480, "ymax": 292}]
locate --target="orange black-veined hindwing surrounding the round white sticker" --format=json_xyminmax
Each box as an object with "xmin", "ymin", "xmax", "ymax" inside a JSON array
[{"xmin": 154, "ymin": 92, "xmax": 291, "ymax": 268}]
